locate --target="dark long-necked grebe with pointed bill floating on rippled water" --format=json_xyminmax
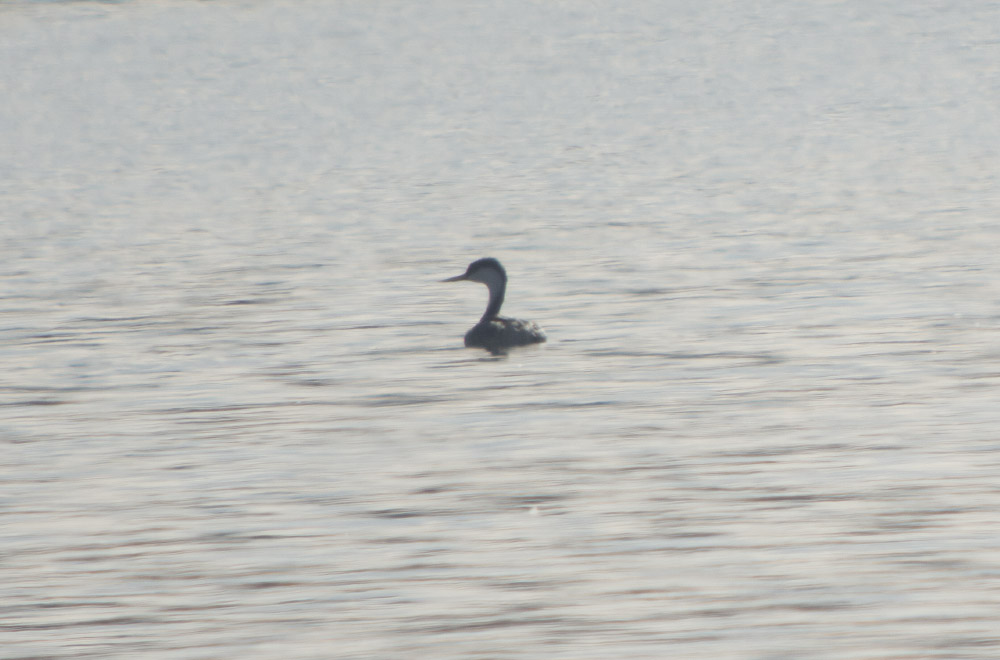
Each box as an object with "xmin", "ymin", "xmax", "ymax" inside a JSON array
[{"xmin": 441, "ymin": 257, "xmax": 545, "ymax": 355}]
